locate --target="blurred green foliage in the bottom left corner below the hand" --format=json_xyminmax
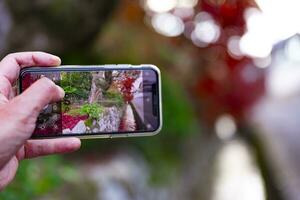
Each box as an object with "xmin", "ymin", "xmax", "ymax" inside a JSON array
[{"xmin": 0, "ymin": 156, "xmax": 65, "ymax": 200}]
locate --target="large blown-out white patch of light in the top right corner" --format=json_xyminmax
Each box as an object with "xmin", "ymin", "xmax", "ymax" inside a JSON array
[{"xmin": 240, "ymin": 0, "xmax": 300, "ymax": 58}]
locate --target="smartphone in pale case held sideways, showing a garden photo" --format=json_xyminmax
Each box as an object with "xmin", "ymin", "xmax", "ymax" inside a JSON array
[{"xmin": 19, "ymin": 65, "xmax": 162, "ymax": 139}]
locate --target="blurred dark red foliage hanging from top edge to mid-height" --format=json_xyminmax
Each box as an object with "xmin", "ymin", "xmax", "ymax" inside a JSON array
[{"xmin": 186, "ymin": 0, "xmax": 265, "ymax": 125}]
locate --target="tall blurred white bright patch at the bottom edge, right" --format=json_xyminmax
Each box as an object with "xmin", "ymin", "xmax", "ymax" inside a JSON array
[{"xmin": 212, "ymin": 140, "xmax": 265, "ymax": 200}]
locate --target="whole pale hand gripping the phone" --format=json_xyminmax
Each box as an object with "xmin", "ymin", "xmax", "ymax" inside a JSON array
[{"xmin": 0, "ymin": 52, "xmax": 80, "ymax": 191}]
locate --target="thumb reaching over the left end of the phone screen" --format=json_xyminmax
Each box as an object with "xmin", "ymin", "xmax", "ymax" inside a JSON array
[{"xmin": 10, "ymin": 77, "xmax": 65, "ymax": 117}]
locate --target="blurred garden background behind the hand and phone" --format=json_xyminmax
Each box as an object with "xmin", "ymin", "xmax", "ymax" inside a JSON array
[{"xmin": 0, "ymin": 0, "xmax": 300, "ymax": 200}]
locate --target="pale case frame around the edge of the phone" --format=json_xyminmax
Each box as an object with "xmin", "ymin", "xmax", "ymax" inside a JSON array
[{"xmin": 18, "ymin": 64, "xmax": 163, "ymax": 139}]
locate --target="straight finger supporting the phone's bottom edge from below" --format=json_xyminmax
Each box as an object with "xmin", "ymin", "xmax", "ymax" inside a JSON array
[{"xmin": 17, "ymin": 137, "xmax": 81, "ymax": 160}]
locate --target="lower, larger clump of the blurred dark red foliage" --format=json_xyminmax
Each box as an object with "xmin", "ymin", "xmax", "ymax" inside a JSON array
[{"xmin": 193, "ymin": 55, "xmax": 265, "ymax": 125}]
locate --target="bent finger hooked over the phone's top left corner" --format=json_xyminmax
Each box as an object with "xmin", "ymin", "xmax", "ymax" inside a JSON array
[{"xmin": 0, "ymin": 52, "xmax": 61, "ymax": 97}]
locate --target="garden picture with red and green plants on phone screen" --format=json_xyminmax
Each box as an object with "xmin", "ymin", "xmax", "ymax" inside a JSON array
[{"xmin": 24, "ymin": 70, "xmax": 149, "ymax": 136}]
